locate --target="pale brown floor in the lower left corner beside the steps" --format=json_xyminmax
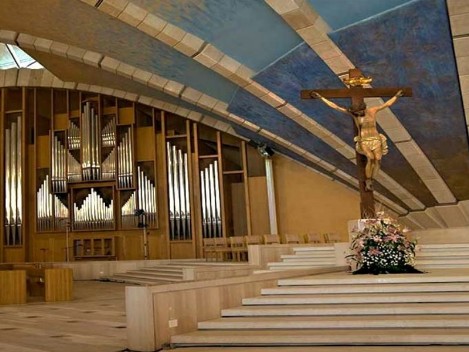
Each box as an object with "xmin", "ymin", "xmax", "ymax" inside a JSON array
[{"xmin": 0, "ymin": 281, "xmax": 127, "ymax": 352}]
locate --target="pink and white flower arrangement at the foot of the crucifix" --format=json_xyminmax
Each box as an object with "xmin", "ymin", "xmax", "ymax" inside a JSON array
[{"xmin": 347, "ymin": 214, "xmax": 421, "ymax": 275}]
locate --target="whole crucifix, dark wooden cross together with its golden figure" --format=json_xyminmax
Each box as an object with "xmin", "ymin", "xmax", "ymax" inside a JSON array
[{"xmin": 301, "ymin": 68, "xmax": 412, "ymax": 219}]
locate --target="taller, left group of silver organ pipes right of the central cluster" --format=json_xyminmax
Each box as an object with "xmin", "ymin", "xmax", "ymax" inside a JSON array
[{"xmin": 166, "ymin": 142, "xmax": 192, "ymax": 241}]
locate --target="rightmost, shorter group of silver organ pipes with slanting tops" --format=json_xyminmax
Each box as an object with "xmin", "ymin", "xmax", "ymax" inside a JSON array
[{"xmin": 200, "ymin": 160, "xmax": 222, "ymax": 238}]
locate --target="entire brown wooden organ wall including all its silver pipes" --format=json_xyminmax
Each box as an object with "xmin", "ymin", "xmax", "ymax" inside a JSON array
[{"xmin": 0, "ymin": 88, "xmax": 262, "ymax": 262}]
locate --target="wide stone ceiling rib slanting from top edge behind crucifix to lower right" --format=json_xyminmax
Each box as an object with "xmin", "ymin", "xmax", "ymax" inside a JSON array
[{"xmin": 265, "ymin": 0, "xmax": 454, "ymax": 205}]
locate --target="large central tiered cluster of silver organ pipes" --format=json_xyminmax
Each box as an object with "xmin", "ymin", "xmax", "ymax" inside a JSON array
[{"xmin": 38, "ymin": 99, "xmax": 158, "ymax": 234}]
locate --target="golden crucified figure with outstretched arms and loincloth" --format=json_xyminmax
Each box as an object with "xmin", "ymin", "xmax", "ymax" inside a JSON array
[{"xmin": 311, "ymin": 90, "xmax": 403, "ymax": 188}]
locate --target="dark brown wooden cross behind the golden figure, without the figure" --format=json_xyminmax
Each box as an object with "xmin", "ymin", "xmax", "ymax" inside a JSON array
[{"xmin": 301, "ymin": 68, "xmax": 412, "ymax": 219}]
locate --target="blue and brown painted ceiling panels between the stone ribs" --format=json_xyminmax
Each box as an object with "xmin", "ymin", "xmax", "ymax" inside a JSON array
[{"xmin": 0, "ymin": 0, "xmax": 469, "ymax": 214}]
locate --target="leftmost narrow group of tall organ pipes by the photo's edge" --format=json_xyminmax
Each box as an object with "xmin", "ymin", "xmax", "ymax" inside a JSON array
[{"xmin": 4, "ymin": 116, "xmax": 23, "ymax": 246}]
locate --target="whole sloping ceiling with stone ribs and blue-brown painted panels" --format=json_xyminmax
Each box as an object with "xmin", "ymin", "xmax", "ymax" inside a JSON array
[{"xmin": 0, "ymin": 0, "xmax": 469, "ymax": 228}]
